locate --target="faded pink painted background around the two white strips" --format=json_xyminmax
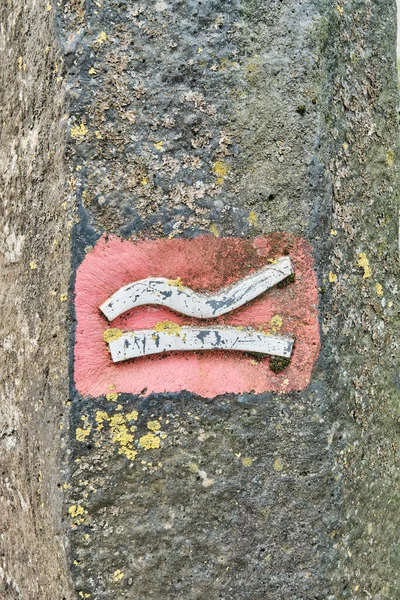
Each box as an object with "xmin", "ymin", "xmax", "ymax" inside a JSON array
[{"xmin": 75, "ymin": 233, "xmax": 320, "ymax": 398}]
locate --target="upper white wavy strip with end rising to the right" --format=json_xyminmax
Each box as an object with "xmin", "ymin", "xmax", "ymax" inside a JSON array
[{"xmin": 100, "ymin": 256, "xmax": 293, "ymax": 321}]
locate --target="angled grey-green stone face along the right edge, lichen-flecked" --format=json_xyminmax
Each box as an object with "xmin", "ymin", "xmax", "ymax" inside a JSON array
[{"xmin": 320, "ymin": 1, "xmax": 400, "ymax": 600}]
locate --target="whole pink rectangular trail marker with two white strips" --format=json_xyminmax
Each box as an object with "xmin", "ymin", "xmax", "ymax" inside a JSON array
[{"xmin": 75, "ymin": 234, "xmax": 319, "ymax": 397}]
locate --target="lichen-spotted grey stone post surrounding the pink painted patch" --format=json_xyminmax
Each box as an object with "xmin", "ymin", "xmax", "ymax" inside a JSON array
[{"xmin": 0, "ymin": 0, "xmax": 400, "ymax": 600}]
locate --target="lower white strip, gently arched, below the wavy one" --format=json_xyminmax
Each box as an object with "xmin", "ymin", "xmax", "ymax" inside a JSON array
[{"xmin": 109, "ymin": 327, "xmax": 294, "ymax": 362}]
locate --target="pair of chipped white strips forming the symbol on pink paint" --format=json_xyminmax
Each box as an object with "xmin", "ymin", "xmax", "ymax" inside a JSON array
[{"xmin": 100, "ymin": 257, "xmax": 294, "ymax": 362}]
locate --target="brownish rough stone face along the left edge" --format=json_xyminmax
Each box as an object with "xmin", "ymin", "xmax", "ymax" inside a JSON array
[{"xmin": 0, "ymin": 0, "xmax": 73, "ymax": 600}]
